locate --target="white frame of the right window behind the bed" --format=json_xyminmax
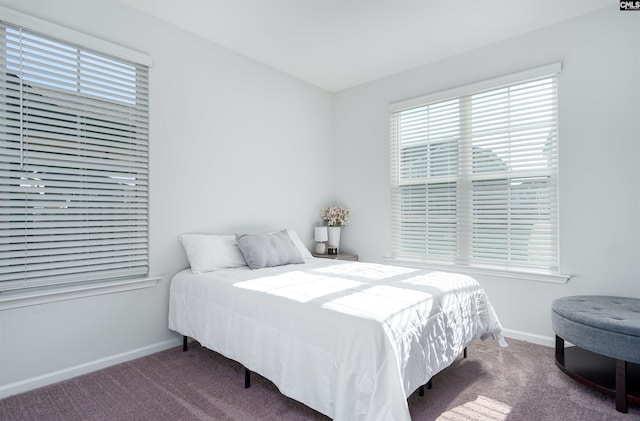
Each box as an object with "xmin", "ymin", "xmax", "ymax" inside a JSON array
[{"xmin": 385, "ymin": 62, "xmax": 570, "ymax": 283}]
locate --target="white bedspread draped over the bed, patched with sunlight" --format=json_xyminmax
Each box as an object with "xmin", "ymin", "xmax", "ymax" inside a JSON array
[{"xmin": 169, "ymin": 259, "xmax": 504, "ymax": 421}]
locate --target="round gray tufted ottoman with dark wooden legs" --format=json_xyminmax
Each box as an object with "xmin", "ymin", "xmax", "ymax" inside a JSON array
[{"xmin": 551, "ymin": 295, "xmax": 640, "ymax": 412}]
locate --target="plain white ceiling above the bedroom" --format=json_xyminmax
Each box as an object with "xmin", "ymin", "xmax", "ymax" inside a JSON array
[{"xmin": 119, "ymin": 0, "xmax": 617, "ymax": 92}]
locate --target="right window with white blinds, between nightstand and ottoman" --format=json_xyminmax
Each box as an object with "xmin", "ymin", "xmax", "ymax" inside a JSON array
[{"xmin": 391, "ymin": 64, "xmax": 560, "ymax": 273}]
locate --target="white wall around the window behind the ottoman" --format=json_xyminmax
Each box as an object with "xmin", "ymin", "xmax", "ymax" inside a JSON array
[{"xmin": 333, "ymin": 6, "xmax": 640, "ymax": 344}]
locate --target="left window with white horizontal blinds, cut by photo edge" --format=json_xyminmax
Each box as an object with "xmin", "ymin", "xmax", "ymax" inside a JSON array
[{"xmin": 0, "ymin": 17, "xmax": 148, "ymax": 291}]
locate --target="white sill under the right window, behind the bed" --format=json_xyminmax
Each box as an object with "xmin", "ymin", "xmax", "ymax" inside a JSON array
[{"xmin": 384, "ymin": 257, "xmax": 571, "ymax": 284}]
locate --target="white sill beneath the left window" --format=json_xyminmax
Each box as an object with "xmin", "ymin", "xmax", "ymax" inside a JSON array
[{"xmin": 0, "ymin": 276, "xmax": 162, "ymax": 311}]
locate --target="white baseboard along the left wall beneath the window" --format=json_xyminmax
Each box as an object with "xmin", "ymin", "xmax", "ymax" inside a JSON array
[{"xmin": 0, "ymin": 338, "xmax": 182, "ymax": 399}]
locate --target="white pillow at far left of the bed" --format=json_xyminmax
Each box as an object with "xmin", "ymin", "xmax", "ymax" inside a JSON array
[{"xmin": 178, "ymin": 234, "xmax": 247, "ymax": 273}]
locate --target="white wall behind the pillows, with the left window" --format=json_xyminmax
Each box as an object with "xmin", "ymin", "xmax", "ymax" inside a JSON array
[{"xmin": 0, "ymin": 0, "xmax": 332, "ymax": 397}]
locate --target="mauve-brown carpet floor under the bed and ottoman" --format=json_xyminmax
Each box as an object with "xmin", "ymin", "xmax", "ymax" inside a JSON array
[{"xmin": 0, "ymin": 339, "xmax": 640, "ymax": 421}]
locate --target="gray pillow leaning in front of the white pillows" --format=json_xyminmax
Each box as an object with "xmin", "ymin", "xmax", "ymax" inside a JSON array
[{"xmin": 236, "ymin": 231, "xmax": 304, "ymax": 269}]
